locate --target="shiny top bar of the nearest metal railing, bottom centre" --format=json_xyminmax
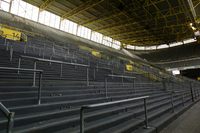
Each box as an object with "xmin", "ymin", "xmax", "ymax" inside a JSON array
[{"xmin": 82, "ymin": 96, "xmax": 149, "ymax": 109}]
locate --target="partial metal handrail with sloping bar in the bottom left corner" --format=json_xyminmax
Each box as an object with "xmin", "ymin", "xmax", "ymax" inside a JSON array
[{"xmin": 0, "ymin": 102, "xmax": 15, "ymax": 133}]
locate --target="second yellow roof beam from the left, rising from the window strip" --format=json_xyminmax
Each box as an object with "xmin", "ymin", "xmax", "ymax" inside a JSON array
[{"xmin": 61, "ymin": 0, "xmax": 104, "ymax": 18}]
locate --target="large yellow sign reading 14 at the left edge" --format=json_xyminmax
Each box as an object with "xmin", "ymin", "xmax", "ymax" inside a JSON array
[{"xmin": 0, "ymin": 26, "xmax": 27, "ymax": 42}]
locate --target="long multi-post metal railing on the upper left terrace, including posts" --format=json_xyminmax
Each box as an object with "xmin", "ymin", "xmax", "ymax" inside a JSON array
[{"xmin": 18, "ymin": 55, "xmax": 90, "ymax": 86}]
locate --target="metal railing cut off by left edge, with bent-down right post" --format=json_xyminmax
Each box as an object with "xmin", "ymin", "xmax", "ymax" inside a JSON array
[{"xmin": 0, "ymin": 67, "xmax": 43, "ymax": 104}]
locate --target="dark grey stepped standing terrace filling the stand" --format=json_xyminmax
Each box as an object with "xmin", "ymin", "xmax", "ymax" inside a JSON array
[{"xmin": 0, "ymin": 35, "xmax": 199, "ymax": 133}]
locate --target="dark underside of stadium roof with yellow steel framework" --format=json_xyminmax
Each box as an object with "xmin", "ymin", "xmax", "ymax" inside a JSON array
[{"xmin": 24, "ymin": 0, "xmax": 200, "ymax": 46}]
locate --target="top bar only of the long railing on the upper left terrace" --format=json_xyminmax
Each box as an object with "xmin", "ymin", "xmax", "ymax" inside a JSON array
[{"xmin": 21, "ymin": 55, "xmax": 89, "ymax": 67}]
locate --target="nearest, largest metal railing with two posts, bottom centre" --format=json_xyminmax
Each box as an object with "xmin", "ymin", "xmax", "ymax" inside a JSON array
[{"xmin": 80, "ymin": 96, "xmax": 149, "ymax": 133}]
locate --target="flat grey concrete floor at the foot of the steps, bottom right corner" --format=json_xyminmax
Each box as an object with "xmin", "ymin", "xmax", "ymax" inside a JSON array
[{"xmin": 160, "ymin": 102, "xmax": 200, "ymax": 133}]
